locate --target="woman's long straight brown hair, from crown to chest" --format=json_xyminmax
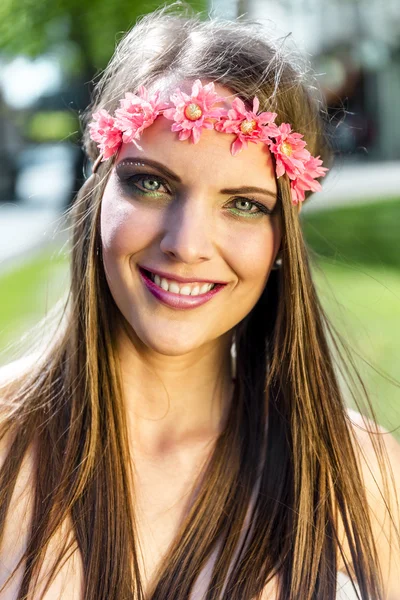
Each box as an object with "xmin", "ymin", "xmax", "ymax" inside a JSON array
[{"xmin": 0, "ymin": 8, "xmax": 394, "ymax": 600}]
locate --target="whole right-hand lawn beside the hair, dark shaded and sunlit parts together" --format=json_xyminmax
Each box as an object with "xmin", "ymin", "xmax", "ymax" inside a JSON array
[{"xmin": 301, "ymin": 198, "xmax": 400, "ymax": 439}]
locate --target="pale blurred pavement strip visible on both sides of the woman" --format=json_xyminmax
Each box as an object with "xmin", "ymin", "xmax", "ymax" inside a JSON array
[{"xmin": 0, "ymin": 161, "xmax": 400, "ymax": 273}]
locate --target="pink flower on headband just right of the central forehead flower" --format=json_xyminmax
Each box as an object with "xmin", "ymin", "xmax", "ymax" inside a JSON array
[{"xmin": 215, "ymin": 96, "xmax": 277, "ymax": 156}]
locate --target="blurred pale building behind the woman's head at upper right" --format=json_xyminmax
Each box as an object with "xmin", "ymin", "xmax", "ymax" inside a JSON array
[{"xmin": 210, "ymin": 0, "xmax": 400, "ymax": 160}]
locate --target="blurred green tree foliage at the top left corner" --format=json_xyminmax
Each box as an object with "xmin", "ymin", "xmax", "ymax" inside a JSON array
[{"xmin": 0, "ymin": 0, "xmax": 207, "ymax": 77}]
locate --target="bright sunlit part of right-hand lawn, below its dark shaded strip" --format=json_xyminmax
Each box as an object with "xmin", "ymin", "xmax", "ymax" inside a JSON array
[{"xmin": 314, "ymin": 259, "xmax": 400, "ymax": 432}]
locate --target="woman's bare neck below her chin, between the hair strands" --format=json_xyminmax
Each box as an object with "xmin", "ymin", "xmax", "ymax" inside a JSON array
[{"xmin": 118, "ymin": 324, "xmax": 233, "ymax": 456}]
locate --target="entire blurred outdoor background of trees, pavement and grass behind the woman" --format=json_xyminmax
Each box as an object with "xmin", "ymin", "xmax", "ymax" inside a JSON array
[{"xmin": 0, "ymin": 0, "xmax": 400, "ymax": 428}]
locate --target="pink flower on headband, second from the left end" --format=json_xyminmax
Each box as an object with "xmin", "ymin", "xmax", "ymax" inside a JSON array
[{"xmin": 115, "ymin": 85, "xmax": 168, "ymax": 149}]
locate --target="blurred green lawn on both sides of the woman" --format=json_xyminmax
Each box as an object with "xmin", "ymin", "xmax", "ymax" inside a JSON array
[{"xmin": 0, "ymin": 198, "xmax": 400, "ymax": 438}]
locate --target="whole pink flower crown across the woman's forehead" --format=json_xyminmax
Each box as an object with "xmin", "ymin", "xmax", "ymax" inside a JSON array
[{"xmin": 89, "ymin": 79, "xmax": 329, "ymax": 204}]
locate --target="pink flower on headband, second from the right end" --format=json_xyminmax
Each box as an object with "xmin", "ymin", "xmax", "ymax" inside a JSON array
[{"xmin": 265, "ymin": 123, "xmax": 311, "ymax": 180}]
